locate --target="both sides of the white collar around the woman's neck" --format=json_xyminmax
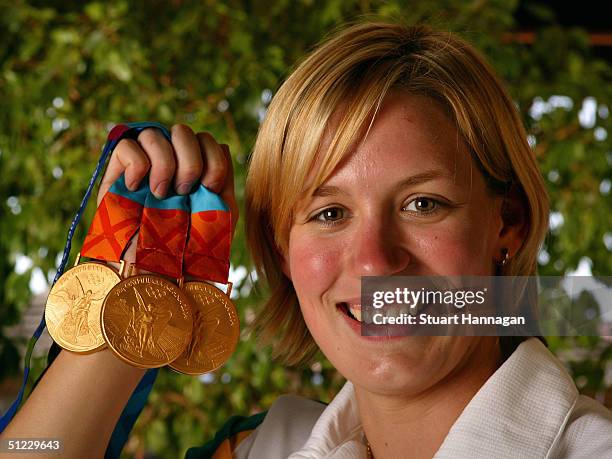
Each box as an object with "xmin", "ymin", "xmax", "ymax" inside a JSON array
[{"xmin": 290, "ymin": 338, "xmax": 578, "ymax": 459}]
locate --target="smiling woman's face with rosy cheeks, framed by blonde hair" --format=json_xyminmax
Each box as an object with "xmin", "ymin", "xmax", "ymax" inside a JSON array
[{"xmin": 284, "ymin": 93, "xmax": 507, "ymax": 394}]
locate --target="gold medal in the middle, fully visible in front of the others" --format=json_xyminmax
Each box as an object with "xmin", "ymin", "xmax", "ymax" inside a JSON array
[{"xmin": 101, "ymin": 274, "xmax": 193, "ymax": 368}]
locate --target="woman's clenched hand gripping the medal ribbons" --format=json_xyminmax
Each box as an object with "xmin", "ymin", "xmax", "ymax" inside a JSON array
[{"xmin": 98, "ymin": 124, "xmax": 238, "ymax": 268}]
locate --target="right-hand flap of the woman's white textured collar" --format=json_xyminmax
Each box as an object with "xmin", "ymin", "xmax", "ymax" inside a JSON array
[{"xmin": 434, "ymin": 338, "xmax": 578, "ymax": 458}]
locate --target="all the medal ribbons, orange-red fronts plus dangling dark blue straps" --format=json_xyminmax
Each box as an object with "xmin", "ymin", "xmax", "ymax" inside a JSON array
[{"xmin": 0, "ymin": 122, "xmax": 231, "ymax": 458}]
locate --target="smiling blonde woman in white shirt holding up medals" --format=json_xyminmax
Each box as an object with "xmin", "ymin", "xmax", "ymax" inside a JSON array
[{"xmin": 5, "ymin": 23, "xmax": 612, "ymax": 458}]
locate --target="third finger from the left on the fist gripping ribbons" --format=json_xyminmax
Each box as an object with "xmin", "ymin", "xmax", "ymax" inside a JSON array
[{"xmin": 171, "ymin": 124, "xmax": 204, "ymax": 194}]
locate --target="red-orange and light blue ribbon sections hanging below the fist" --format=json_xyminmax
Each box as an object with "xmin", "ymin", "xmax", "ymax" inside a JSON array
[{"xmin": 81, "ymin": 124, "xmax": 232, "ymax": 283}]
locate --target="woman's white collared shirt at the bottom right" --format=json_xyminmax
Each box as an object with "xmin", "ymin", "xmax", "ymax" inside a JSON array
[{"xmin": 235, "ymin": 338, "xmax": 612, "ymax": 459}]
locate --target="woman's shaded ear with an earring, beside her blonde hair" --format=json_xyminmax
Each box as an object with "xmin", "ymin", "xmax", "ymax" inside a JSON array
[{"xmin": 493, "ymin": 185, "xmax": 529, "ymax": 262}]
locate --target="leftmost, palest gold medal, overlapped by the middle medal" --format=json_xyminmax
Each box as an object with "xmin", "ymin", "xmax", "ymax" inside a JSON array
[{"xmin": 45, "ymin": 263, "xmax": 121, "ymax": 353}]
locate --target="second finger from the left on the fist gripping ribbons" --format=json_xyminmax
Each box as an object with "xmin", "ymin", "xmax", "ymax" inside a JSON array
[{"xmin": 138, "ymin": 129, "xmax": 176, "ymax": 199}]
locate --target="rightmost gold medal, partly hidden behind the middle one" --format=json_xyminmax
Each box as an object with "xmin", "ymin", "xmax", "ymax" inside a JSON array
[{"xmin": 170, "ymin": 282, "xmax": 240, "ymax": 375}]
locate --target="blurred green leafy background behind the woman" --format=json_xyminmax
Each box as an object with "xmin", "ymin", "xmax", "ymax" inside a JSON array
[{"xmin": 0, "ymin": 0, "xmax": 612, "ymax": 458}]
